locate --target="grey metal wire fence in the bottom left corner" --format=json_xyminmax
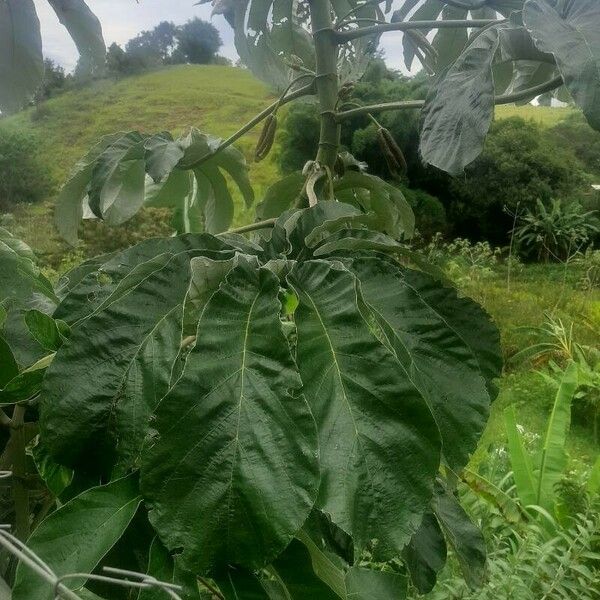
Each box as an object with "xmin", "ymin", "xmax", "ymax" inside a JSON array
[{"xmin": 0, "ymin": 524, "xmax": 182, "ymax": 600}]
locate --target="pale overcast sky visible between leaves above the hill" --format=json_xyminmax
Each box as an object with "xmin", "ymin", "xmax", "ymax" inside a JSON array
[{"xmin": 34, "ymin": 0, "xmax": 408, "ymax": 70}]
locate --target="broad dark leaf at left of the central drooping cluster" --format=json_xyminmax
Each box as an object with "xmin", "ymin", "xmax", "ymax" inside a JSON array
[{"xmin": 40, "ymin": 253, "xmax": 195, "ymax": 470}]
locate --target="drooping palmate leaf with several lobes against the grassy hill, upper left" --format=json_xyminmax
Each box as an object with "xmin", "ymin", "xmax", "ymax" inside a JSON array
[{"xmin": 55, "ymin": 129, "xmax": 254, "ymax": 244}]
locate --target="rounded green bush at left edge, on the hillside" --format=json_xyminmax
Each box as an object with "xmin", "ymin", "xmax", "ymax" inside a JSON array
[{"xmin": 0, "ymin": 127, "xmax": 52, "ymax": 210}]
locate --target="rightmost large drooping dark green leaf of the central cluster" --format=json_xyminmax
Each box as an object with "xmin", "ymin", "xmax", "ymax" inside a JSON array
[{"xmin": 352, "ymin": 257, "xmax": 490, "ymax": 470}]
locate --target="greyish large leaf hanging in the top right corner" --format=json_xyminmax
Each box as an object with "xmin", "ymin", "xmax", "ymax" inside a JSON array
[{"xmin": 523, "ymin": 0, "xmax": 600, "ymax": 130}]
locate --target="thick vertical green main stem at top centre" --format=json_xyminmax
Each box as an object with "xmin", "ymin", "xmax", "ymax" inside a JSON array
[{"xmin": 309, "ymin": 0, "xmax": 340, "ymax": 170}]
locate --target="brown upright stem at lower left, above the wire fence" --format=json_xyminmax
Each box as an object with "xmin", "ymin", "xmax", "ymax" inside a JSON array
[{"xmin": 11, "ymin": 404, "xmax": 30, "ymax": 541}]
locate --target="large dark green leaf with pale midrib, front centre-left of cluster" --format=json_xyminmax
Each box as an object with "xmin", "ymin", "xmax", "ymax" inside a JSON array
[{"xmin": 142, "ymin": 263, "xmax": 319, "ymax": 571}]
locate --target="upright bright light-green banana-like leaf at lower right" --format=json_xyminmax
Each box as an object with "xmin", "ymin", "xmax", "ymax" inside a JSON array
[{"xmin": 534, "ymin": 362, "xmax": 578, "ymax": 512}]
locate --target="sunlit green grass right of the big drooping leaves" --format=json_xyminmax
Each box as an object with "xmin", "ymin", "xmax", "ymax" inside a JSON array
[{"xmin": 461, "ymin": 264, "xmax": 600, "ymax": 466}]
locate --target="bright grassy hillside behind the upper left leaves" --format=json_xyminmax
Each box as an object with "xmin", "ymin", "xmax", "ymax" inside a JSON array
[{"xmin": 4, "ymin": 65, "xmax": 277, "ymax": 254}]
